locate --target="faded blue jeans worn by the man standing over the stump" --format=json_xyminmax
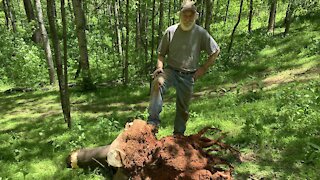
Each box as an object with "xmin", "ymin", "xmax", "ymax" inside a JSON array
[{"xmin": 148, "ymin": 68, "xmax": 194, "ymax": 134}]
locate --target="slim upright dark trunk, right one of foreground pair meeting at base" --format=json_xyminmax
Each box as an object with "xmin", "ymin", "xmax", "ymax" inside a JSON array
[{"xmin": 61, "ymin": 0, "xmax": 71, "ymax": 128}]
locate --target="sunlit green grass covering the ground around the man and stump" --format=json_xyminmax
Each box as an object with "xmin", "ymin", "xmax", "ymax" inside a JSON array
[{"xmin": 0, "ymin": 9, "xmax": 320, "ymax": 179}]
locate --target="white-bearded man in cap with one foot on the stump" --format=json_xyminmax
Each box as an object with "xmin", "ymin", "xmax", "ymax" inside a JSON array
[{"xmin": 148, "ymin": 0, "xmax": 220, "ymax": 135}]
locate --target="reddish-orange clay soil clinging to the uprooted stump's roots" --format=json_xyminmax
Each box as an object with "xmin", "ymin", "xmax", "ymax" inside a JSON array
[{"xmin": 120, "ymin": 120, "xmax": 237, "ymax": 180}]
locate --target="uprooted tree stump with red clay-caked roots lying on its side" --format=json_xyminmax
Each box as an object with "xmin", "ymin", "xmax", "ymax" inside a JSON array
[{"xmin": 67, "ymin": 119, "xmax": 240, "ymax": 180}]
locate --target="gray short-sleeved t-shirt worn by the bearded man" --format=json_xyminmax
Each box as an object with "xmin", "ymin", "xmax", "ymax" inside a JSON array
[{"xmin": 158, "ymin": 24, "xmax": 219, "ymax": 72}]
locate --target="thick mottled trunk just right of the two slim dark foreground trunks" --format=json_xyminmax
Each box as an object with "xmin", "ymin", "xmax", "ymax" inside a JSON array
[{"xmin": 72, "ymin": 0, "xmax": 95, "ymax": 90}]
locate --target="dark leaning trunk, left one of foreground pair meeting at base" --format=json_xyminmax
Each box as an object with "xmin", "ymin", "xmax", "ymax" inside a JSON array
[{"xmin": 46, "ymin": 0, "xmax": 71, "ymax": 128}]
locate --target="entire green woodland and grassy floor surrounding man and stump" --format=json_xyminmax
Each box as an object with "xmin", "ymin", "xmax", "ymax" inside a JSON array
[{"xmin": 0, "ymin": 0, "xmax": 320, "ymax": 179}]
